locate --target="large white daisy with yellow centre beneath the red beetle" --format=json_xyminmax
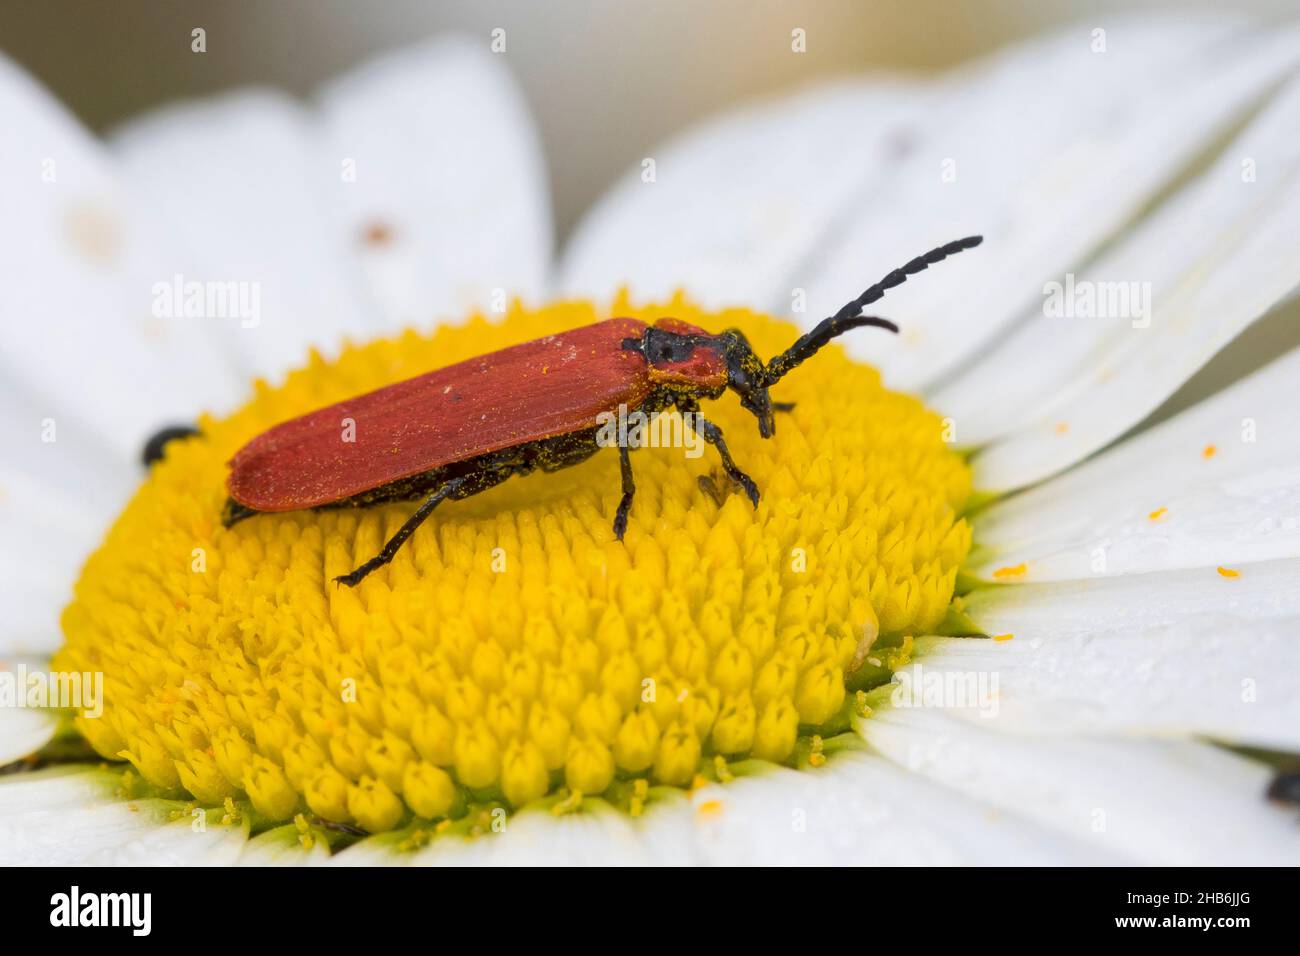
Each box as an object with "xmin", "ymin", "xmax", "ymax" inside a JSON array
[{"xmin": 0, "ymin": 16, "xmax": 1300, "ymax": 864}]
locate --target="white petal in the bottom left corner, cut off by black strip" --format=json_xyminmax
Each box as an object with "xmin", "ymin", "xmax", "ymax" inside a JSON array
[{"xmin": 0, "ymin": 767, "xmax": 248, "ymax": 866}]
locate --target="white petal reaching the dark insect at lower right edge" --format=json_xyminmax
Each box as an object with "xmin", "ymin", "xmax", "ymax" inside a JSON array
[{"xmin": 858, "ymin": 705, "xmax": 1300, "ymax": 865}]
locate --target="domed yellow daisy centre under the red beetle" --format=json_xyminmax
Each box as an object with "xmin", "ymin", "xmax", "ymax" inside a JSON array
[{"xmin": 55, "ymin": 299, "xmax": 970, "ymax": 831}]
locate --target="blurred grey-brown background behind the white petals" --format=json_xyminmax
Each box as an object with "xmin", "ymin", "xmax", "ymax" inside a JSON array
[{"xmin": 0, "ymin": 0, "xmax": 1300, "ymax": 414}]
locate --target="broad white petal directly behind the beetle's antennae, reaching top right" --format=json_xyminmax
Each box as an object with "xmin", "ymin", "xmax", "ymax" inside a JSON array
[{"xmin": 811, "ymin": 17, "xmax": 1300, "ymax": 390}]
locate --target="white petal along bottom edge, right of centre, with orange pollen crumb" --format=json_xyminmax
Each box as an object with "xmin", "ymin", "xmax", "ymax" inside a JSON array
[{"xmin": 686, "ymin": 753, "xmax": 1119, "ymax": 866}]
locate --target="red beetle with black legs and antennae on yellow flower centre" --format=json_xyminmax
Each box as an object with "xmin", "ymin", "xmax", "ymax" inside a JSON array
[{"xmin": 222, "ymin": 235, "xmax": 982, "ymax": 587}]
